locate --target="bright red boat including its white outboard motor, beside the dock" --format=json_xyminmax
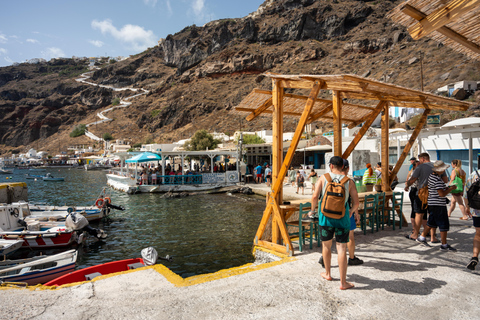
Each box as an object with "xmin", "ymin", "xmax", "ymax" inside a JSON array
[{"xmin": 44, "ymin": 247, "xmax": 172, "ymax": 287}]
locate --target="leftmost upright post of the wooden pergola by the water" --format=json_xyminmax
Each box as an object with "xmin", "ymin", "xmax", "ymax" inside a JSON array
[{"xmin": 272, "ymin": 79, "xmax": 283, "ymax": 243}]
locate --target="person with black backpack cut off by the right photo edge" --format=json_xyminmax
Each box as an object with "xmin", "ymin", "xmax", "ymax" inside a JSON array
[{"xmin": 465, "ymin": 170, "xmax": 480, "ymax": 270}]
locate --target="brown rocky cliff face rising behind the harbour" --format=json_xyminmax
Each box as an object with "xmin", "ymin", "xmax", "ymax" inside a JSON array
[{"xmin": 0, "ymin": 0, "xmax": 480, "ymax": 153}]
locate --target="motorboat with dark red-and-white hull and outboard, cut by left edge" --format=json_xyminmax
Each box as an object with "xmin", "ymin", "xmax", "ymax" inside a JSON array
[{"xmin": 0, "ymin": 201, "xmax": 106, "ymax": 249}]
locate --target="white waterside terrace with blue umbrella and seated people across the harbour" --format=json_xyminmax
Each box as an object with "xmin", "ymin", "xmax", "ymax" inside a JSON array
[{"xmin": 107, "ymin": 150, "xmax": 240, "ymax": 193}]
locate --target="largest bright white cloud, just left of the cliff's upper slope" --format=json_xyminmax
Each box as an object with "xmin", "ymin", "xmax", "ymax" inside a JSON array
[{"xmin": 92, "ymin": 19, "xmax": 157, "ymax": 51}]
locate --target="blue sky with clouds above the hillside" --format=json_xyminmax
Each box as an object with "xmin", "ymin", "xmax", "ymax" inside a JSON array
[{"xmin": 0, "ymin": 0, "xmax": 264, "ymax": 67}]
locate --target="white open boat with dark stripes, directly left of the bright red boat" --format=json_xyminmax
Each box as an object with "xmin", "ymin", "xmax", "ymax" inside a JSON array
[{"xmin": 0, "ymin": 250, "xmax": 77, "ymax": 285}]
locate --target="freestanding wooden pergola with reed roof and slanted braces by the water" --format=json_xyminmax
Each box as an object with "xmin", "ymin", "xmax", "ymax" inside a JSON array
[{"xmin": 234, "ymin": 73, "xmax": 470, "ymax": 255}]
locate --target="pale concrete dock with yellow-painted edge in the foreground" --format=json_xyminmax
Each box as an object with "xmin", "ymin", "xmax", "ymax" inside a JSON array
[{"xmin": 0, "ymin": 184, "xmax": 480, "ymax": 319}]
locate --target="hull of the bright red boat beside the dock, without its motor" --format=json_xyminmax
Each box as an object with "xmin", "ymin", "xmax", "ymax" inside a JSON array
[{"xmin": 45, "ymin": 258, "xmax": 145, "ymax": 286}]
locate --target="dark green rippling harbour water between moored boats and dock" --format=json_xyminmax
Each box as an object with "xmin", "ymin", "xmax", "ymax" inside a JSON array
[{"xmin": 5, "ymin": 169, "xmax": 265, "ymax": 277}]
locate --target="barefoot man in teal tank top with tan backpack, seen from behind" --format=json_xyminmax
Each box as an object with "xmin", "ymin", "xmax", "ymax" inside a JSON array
[{"xmin": 310, "ymin": 156, "xmax": 359, "ymax": 290}]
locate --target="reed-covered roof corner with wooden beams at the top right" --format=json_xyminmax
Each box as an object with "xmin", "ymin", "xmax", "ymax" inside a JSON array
[{"xmin": 387, "ymin": 0, "xmax": 480, "ymax": 60}]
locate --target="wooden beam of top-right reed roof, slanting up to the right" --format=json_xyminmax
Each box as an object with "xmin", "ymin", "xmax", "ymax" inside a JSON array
[{"xmin": 408, "ymin": 0, "xmax": 480, "ymax": 40}]
